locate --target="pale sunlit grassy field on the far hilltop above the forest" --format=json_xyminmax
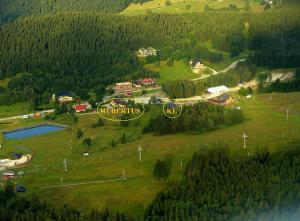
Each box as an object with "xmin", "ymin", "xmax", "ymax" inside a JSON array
[{"xmin": 122, "ymin": 0, "xmax": 263, "ymax": 15}]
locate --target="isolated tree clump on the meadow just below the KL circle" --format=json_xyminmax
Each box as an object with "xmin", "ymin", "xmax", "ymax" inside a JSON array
[{"xmin": 143, "ymin": 102, "xmax": 244, "ymax": 135}]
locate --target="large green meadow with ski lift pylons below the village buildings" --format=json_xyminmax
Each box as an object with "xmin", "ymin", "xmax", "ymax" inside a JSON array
[{"xmin": 0, "ymin": 93, "xmax": 300, "ymax": 219}]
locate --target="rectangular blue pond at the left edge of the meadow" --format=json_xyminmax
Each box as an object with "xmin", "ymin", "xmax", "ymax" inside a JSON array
[{"xmin": 3, "ymin": 124, "xmax": 65, "ymax": 139}]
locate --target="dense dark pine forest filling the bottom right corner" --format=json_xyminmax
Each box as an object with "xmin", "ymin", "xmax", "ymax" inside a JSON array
[{"xmin": 145, "ymin": 143, "xmax": 300, "ymax": 221}]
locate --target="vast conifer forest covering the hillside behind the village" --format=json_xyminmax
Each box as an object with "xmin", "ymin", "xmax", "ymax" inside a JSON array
[{"xmin": 0, "ymin": 9, "xmax": 300, "ymax": 104}]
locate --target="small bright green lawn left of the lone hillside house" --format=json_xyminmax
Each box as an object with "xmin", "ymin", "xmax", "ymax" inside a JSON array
[{"xmin": 144, "ymin": 61, "xmax": 199, "ymax": 84}]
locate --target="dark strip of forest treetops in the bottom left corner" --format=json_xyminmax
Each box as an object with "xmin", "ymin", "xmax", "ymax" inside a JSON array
[{"xmin": 0, "ymin": 182, "xmax": 133, "ymax": 221}]
